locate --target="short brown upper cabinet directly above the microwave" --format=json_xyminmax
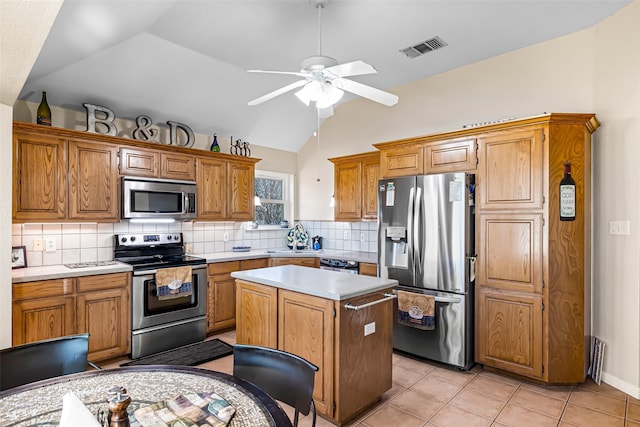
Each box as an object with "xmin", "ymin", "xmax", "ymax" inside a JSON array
[{"xmin": 120, "ymin": 147, "xmax": 196, "ymax": 181}]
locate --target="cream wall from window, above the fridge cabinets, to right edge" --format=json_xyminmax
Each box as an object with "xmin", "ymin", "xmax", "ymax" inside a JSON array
[{"xmin": 298, "ymin": 0, "xmax": 640, "ymax": 397}]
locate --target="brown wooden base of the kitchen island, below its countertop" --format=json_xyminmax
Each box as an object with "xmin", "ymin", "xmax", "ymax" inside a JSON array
[{"xmin": 236, "ymin": 279, "xmax": 393, "ymax": 425}]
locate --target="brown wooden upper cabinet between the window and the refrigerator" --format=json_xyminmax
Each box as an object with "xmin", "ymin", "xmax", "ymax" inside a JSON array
[{"xmin": 329, "ymin": 151, "xmax": 380, "ymax": 221}]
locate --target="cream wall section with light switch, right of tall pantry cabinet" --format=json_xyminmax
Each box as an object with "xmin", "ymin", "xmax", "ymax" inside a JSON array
[{"xmin": 592, "ymin": 1, "xmax": 640, "ymax": 397}]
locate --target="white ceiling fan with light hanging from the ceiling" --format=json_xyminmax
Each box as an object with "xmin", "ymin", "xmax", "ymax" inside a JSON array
[{"xmin": 248, "ymin": 0, "xmax": 398, "ymax": 117}]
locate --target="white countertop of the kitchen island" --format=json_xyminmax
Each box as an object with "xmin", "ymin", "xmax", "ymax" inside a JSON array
[{"xmin": 231, "ymin": 265, "xmax": 398, "ymax": 301}]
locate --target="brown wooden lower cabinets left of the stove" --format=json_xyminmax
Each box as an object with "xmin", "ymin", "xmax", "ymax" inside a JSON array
[{"xmin": 13, "ymin": 273, "xmax": 131, "ymax": 361}]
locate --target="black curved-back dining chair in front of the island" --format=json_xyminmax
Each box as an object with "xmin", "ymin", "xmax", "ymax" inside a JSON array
[{"xmin": 233, "ymin": 344, "xmax": 318, "ymax": 427}]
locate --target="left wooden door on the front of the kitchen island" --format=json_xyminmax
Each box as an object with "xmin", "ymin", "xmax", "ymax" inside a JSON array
[{"xmin": 236, "ymin": 280, "xmax": 278, "ymax": 348}]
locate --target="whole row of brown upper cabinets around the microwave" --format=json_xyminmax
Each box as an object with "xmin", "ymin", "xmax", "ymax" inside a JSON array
[{"xmin": 12, "ymin": 122, "xmax": 260, "ymax": 222}]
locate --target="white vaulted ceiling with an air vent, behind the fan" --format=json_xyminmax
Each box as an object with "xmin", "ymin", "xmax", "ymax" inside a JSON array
[{"xmin": 19, "ymin": 0, "xmax": 629, "ymax": 152}]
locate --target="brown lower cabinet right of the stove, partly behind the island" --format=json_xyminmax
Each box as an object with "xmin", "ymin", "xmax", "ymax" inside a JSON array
[{"xmin": 207, "ymin": 258, "xmax": 268, "ymax": 333}]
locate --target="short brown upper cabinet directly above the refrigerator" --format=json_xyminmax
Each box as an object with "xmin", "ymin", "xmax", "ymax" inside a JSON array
[{"xmin": 374, "ymin": 135, "xmax": 477, "ymax": 178}]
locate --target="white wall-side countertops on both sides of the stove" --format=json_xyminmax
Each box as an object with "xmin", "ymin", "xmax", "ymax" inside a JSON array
[{"xmin": 11, "ymin": 249, "xmax": 378, "ymax": 283}]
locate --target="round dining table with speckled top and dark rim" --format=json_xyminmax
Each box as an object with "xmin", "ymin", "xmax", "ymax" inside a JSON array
[{"xmin": 0, "ymin": 365, "xmax": 291, "ymax": 427}]
